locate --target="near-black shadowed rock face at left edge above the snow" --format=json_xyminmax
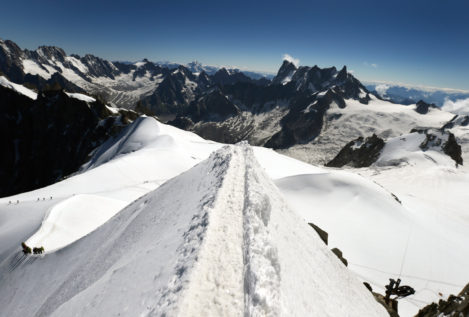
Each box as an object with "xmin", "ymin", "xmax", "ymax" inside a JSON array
[{"xmin": 0, "ymin": 87, "xmax": 136, "ymax": 197}]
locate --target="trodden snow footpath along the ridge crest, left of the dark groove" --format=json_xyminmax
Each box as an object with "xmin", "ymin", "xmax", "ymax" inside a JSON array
[{"xmin": 175, "ymin": 146, "xmax": 244, "ymax": 316}]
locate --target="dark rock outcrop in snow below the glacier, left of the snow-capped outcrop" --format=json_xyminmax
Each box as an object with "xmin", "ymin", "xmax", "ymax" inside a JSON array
[{"xmin": 326, "ymin": 134, "xmax": 385, "ymax": 167}]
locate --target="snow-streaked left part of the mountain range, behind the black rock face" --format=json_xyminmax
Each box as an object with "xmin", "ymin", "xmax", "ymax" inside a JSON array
[{"xmin": 0, "ymin": 40, "xmax": 268, "ymax": 115}]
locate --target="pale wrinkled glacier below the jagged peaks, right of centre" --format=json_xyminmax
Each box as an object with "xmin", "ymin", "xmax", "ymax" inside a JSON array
[{"xmin": 281, "ymin": 95, "xmax": 454, "ymax": 165}]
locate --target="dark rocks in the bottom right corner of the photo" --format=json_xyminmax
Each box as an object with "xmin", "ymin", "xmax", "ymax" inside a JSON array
[{"xmin": 415, "ymin": 284, "xmax": 469, "ymax": 317}]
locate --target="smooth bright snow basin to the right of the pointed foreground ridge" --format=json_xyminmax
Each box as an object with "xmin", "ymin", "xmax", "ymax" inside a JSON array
[{"xmin": 276, "ymin": 155, "xmax": 469, "ymax": 316}]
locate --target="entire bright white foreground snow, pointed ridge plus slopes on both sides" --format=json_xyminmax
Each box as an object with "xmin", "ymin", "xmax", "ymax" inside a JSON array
[{"xmin": 0, "ymin": 113, "xmax": 469, "ymax": 316}]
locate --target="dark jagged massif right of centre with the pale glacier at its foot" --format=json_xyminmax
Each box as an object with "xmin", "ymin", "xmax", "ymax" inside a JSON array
[{"xmin": 170, "ymin": 60, "xmax": 454, "ymax": 164}]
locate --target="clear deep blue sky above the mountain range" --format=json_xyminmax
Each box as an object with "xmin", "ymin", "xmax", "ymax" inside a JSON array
[{"xmin": 0, "ymin": 0, "xmax": 469, "ymax": 90}]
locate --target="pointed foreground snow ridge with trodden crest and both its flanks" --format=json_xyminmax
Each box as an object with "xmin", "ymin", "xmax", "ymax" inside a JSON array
[{"xmin": 0, "ymin": 145, "xmax": 386, "ymax": 316}]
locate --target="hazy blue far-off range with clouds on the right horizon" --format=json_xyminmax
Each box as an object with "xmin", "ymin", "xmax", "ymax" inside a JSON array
[{"xmin": 365, "ymin": 83, "xmax": 469, "ymax": 107}]
